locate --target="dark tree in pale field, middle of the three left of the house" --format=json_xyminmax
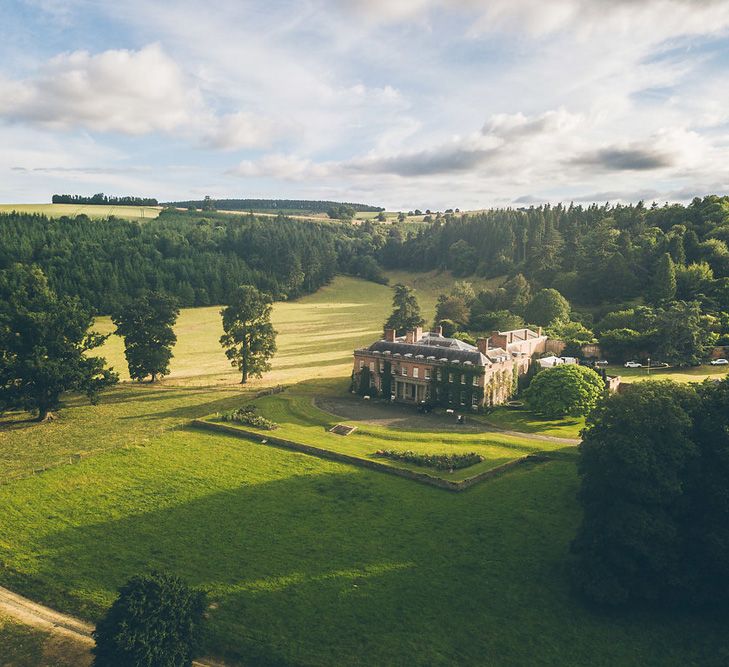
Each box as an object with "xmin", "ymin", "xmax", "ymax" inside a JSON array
[{"xmin": 112, "ymin": 292, "xmax": 180, "ymax": 382}]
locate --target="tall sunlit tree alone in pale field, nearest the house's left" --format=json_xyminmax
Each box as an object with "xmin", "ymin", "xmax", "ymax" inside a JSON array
[{"xmin": 220, "ymin": 285, "xmax": 276, "ymax": 384}]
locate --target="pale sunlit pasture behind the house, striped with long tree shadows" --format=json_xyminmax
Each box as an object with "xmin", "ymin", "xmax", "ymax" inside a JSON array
[{"xmin": 96, "ymin": 272, "xmax": 489, "ymax": 385}]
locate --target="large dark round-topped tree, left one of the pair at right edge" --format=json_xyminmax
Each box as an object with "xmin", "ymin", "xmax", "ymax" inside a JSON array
[{"xmin": 568, "ymin": 380, "xmax": 700, "ymax": 605}]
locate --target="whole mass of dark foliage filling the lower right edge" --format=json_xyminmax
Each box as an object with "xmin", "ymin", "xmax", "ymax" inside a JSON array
[{"xmin": 573, "ymin": 379, "xmax": 729, "ymax": 605}]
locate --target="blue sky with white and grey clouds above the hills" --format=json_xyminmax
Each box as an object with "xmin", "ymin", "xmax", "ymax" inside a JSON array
[{"xmin": 0, "ymin": 0, "xmax": 729, "ymax": 210}]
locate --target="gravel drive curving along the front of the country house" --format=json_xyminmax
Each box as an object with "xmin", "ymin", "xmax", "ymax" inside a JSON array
[{"xmin": 313, "ymin": 396, "xmax": 581, "ymax": 445}]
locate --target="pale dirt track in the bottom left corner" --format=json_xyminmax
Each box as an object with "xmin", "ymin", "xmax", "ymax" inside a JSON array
[{"xmin": 0, "ymin": 586, "xmax": 225, "ymax": 667}]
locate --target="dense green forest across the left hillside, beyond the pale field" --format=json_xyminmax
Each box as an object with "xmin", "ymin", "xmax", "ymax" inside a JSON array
[{"xmin": 0, "ymin": 210, "xmax": 385, "ymax": 314}]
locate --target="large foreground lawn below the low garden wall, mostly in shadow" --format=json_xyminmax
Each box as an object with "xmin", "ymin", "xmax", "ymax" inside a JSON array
[{"xmin": 0, "ymin": 428, "xmax": 729, "ymax": 665}]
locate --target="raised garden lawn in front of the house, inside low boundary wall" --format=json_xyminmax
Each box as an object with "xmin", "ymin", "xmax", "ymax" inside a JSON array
[{"xmin": 202, "ymin": 381, "xmax": 573, "ymax": 481}]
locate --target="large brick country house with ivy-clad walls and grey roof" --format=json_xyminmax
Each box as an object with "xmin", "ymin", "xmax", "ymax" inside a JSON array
[{"xmin": 353, "ymin": 327, "xmax": 547, "ymax": 409}]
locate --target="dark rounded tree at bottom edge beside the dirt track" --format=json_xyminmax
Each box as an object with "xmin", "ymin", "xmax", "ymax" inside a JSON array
[{"xmin": 93, "ymin": 572, "xmax": 206, "ymax": 667}]
